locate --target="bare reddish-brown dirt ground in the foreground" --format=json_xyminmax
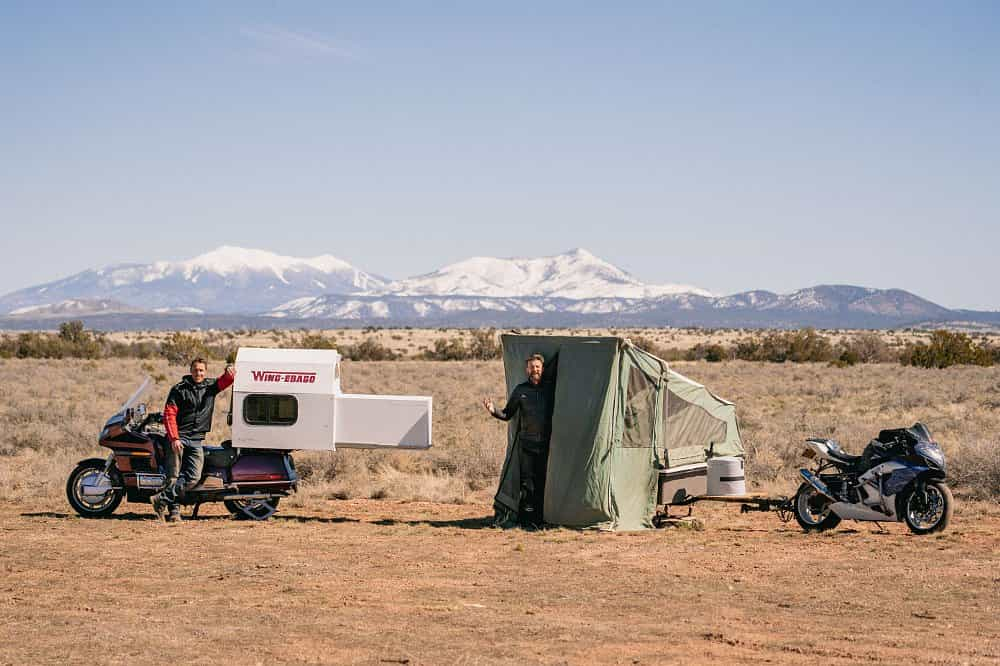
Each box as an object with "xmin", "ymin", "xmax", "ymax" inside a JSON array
[{"xmin": 0, "ymin": 499, "xmax": 1000, "ymax": 664}]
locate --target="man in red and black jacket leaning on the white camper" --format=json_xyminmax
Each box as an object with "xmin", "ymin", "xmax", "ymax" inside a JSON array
[{"xmin": 151, "ymin": 358, "xmax": 236, "ymax": 522}]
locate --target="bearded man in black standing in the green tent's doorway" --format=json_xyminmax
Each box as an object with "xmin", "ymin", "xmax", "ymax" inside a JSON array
[{"xmin": 483, "ymin": 354, "xmax": 555, "ymax": 527}]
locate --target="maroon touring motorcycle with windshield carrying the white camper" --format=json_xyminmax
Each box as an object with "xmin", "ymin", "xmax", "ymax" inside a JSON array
[{"xmin": 66, "ymin": 377, "xmax": 298, "ymax": 520}]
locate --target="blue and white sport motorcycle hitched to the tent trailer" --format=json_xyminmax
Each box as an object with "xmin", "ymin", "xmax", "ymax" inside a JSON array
[{"xmin": 793, "ymin": 423, "xmax": 954, "ymax": 534}]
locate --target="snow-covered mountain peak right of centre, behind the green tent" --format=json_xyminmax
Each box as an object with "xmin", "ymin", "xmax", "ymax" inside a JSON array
[{"xmin": 382, "ymin": 249, "xmax": 712, "ymax": 299}]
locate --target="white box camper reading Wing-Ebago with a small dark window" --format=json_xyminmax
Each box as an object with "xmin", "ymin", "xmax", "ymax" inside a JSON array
[{"xmin": 232, "ymin": 347, "xmax": 431, "ymax": 451}]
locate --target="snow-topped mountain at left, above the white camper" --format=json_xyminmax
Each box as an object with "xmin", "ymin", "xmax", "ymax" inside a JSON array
[{"xmin": 0, "ymin": 246, "xmax": 386, "ymax": 313}]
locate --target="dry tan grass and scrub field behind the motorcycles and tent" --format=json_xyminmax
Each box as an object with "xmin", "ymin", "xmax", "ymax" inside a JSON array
[{"xmin": 0, "ymin": 360, "xmax": 1000, "ymax": 503}]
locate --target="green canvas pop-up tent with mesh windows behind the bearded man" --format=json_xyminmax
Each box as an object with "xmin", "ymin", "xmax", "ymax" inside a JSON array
[{"xmin": 495, "ymin": 334, "xmax": 743, "ymax": 530}]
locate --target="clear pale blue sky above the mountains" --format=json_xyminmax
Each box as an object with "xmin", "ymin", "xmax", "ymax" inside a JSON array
[{"xmin": 0, "ymin": 1, "xmax": 1000, "ymax": 309}]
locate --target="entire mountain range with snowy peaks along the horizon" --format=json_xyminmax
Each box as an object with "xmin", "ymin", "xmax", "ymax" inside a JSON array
[{"xmin": 0, "ymin": 246, "xmax": 1000, "ymax": 329}]
